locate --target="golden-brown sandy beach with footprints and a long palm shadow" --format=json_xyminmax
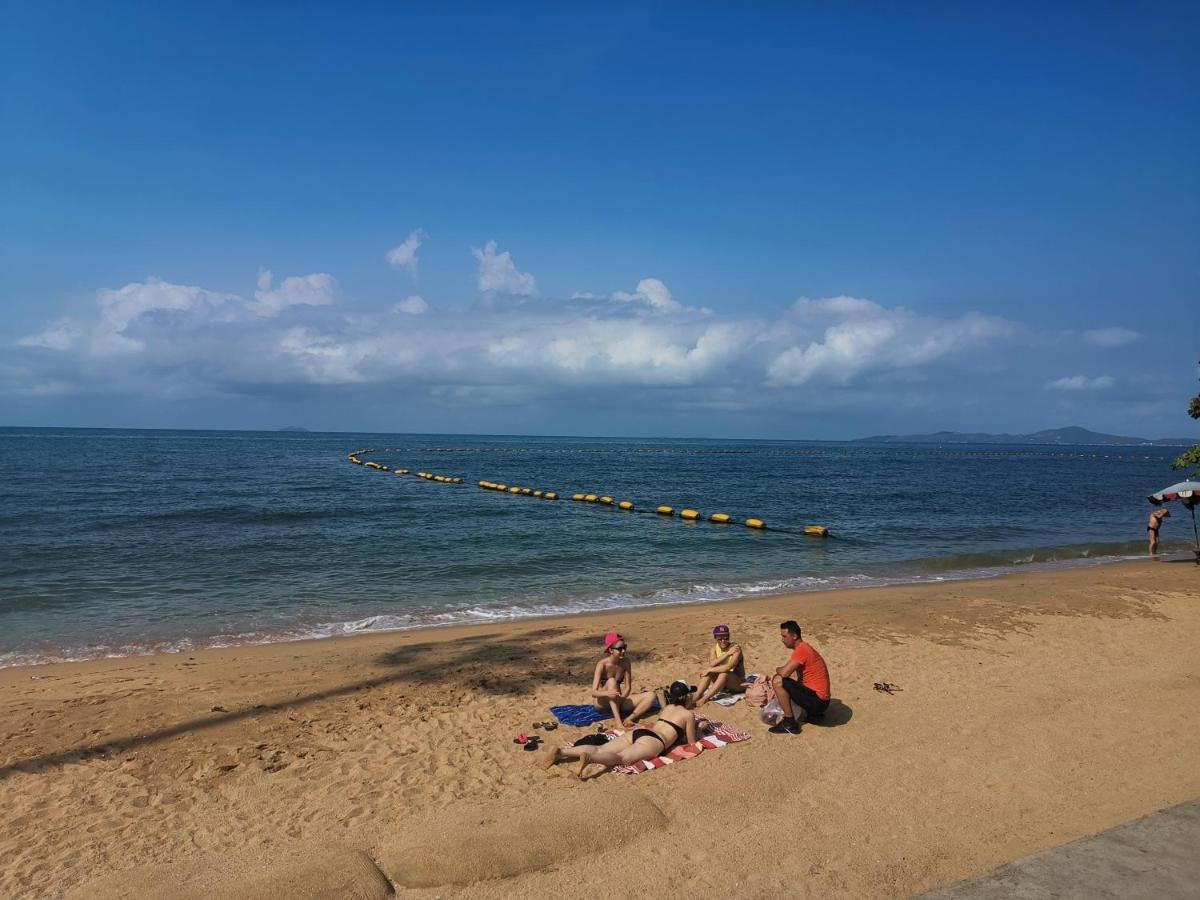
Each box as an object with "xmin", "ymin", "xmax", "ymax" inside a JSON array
[{"xmin": 0, "ymin": 562, "xmax": 1200, "ymax": 900}]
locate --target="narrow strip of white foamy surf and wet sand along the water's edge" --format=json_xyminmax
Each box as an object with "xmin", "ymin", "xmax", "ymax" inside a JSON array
[{"xmin": 0, "ymin": 548, "xmax": 1161, "ymax": 672}]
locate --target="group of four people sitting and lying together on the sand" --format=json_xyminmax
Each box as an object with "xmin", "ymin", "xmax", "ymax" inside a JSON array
[{"xmin": 544, "ymin": 619, "xmax": 829, "ymax": 779}]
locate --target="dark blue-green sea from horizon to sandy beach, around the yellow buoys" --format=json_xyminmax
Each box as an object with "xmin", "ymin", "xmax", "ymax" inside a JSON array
[{"xmin": 0, "ymin": 428, "xmax": 1190, "ymax": 666}]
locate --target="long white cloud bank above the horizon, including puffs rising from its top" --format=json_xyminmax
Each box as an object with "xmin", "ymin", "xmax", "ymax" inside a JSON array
[{"xmin": 0, "ymin": 240, "xmax": 1180, "ymax": 433}]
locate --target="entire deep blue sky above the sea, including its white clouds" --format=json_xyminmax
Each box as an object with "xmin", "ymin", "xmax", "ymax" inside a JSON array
[{"xmin": 0, "ymin": 2, "xmax": 1200, "ymax": 438}]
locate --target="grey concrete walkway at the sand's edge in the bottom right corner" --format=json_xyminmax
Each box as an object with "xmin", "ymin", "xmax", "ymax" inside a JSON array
[{"xmin": 924, "ymin": 800, "xmax": 1200, "ymax": 900}]
